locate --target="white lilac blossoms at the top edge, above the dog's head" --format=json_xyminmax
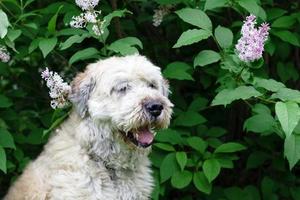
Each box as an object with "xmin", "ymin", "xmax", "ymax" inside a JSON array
[{"xmin": 70, "ymin": 0, "xmax": 104, "ymax": 36}]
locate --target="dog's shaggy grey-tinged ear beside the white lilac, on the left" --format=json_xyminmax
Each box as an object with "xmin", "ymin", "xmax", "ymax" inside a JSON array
[{"xmin": 69, "ymin": 72, "xmax": 96, "ymax": 118}]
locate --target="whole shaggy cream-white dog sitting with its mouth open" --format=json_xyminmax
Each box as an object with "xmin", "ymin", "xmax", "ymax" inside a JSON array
[{"xmin": 5, "ymin": 55, "xmax": 172, "ymax": 200}]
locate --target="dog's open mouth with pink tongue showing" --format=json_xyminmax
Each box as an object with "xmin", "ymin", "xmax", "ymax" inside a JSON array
[{"xmin": 121, "ymin": 128, "xmax": 154, "ymax": 148}]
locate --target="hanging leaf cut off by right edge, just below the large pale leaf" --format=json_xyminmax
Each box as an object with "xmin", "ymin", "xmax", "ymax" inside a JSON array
[{"xmin": 284, "ymin": 134, "xmax": 300, "ymax": 170}]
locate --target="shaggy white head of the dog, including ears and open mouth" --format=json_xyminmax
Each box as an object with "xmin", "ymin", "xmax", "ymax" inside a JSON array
[{"xmin": 70, "ymin": 55, "xmax": 173, "ymax": 148}]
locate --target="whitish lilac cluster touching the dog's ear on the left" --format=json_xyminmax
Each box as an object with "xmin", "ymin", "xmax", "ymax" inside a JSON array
[{"xmin": 41, "ymin": 68, "xmax": 71, "ymax": 109}]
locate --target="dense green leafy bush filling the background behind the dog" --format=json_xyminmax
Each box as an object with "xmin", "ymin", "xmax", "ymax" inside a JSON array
[{"xmin": 0, "ymin": 0, "xmax": 300, "ymax": 200}]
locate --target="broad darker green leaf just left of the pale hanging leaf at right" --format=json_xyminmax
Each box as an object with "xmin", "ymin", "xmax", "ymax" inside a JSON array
[{"xmin": 244, "ymin": 113, "xmax": 276, "ymax": 133}]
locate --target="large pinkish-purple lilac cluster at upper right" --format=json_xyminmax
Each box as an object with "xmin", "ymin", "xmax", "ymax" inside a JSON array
[{"xmin": 235, "ymin": 15, "xmax": 270, "ymax": 62}]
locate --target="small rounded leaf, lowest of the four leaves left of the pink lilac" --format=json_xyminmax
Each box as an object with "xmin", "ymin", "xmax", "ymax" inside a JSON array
[{"xmin": 194, "ymin": 50, "xmax": 221, "ymax": 67}]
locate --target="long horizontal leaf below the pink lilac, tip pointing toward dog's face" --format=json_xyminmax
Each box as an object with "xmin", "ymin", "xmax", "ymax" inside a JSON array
[{"xmin": 212, "ymin": 86, "xmax": 262, "ymax": 106}]
